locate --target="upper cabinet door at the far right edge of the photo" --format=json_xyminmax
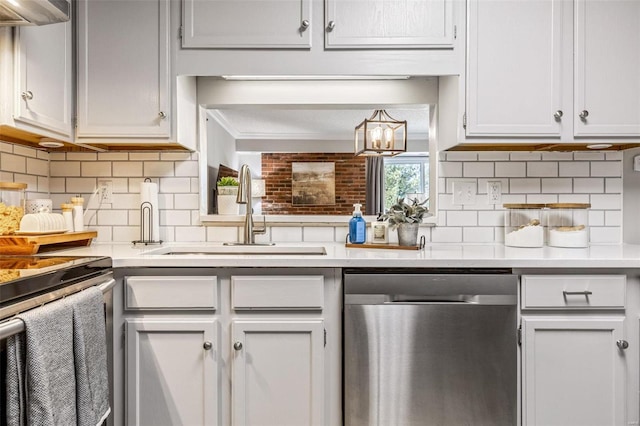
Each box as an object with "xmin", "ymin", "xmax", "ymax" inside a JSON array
[{"xmin": 574, "ymin": 0, "xmax": 640, "ymax": 136}]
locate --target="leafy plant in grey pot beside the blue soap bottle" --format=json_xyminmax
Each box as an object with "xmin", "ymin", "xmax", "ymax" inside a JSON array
[{"xmin": 382, "ymin": 197, "xmax": 432, "ymax": 246}]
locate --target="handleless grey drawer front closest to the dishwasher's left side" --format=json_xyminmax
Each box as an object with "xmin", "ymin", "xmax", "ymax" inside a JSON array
[{"xmin": 231, "ymin": 275, "xmax": 324, "ymax": 310}]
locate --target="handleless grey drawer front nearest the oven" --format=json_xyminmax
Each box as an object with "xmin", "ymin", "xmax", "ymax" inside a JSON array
[{"xmin": 124, "ymin": 276, "xmax": 218, "ymax": 310}]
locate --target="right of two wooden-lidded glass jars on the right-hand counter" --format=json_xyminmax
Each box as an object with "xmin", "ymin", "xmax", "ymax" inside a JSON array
[{"xmin": 547, "ymin": 203, "xmax": 591, "ymax": 247}]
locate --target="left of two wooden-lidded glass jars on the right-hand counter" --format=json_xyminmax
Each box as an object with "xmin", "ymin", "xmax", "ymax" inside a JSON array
[{"xmin": 503, "ymin": 204, "xmax": 545, "ymax": 247}]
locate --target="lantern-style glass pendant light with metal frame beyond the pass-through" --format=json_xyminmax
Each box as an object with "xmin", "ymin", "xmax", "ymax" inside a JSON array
[{"xmin": 355, "ymin": 109, "xmax": 407, "ymax": 157}]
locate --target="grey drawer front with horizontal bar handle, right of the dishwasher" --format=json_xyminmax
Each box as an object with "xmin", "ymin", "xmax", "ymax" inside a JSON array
[{"xmin": 522, "ymin": 275, "xmax": 626, "ymax": 309}]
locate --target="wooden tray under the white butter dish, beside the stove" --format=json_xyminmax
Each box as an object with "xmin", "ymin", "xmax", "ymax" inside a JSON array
[{"xmin": 0, "ymin": 231, "xmax": 98, "ymax": 255}]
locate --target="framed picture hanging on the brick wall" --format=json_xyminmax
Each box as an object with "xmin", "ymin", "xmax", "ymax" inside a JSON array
[{"xmin": 291, "ymin": 162, "xmax": 336, "ymax": 206}]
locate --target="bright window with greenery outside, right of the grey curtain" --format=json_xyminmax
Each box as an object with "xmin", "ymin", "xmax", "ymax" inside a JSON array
[{"xmin": 384, "ymin": 153, "xmax": 429, "ymax": 210}]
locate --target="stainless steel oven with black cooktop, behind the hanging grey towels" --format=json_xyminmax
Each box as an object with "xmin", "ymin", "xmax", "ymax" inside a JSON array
[{"xmin": 0, "ymin": 256, "xmax": 115, "ymax": 425}]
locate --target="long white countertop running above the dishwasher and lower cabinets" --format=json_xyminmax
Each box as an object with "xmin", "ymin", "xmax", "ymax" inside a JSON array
[{"xmin": 51, "ymin": 242, "xmax": 640, "ymax": 269}]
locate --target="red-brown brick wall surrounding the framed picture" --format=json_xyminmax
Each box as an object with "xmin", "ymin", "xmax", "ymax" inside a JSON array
[{"xmin": 262, "ymin": 153, "xmax": 366, "ymax": 215}]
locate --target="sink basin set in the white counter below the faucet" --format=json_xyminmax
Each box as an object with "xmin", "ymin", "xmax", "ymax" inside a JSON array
[{"xmin": 146, "ymin": 245, "xmax": 327, "ymax": 256}]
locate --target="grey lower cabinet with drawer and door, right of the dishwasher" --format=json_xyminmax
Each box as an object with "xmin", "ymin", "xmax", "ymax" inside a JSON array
[{"xmin": 521, "ymin": 275, "xmax": 636, "ymax": 426}]
